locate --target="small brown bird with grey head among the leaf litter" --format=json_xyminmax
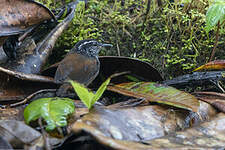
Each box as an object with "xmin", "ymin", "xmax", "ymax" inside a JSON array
[{"xmin": 54, "ymin": 39, "xmax": 112, "ymax": 95}]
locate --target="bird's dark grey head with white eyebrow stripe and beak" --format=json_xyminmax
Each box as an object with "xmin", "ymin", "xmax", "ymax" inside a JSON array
[{"xmin": 71, "ymin": 39, "xmax": 112, "ymax": 57}]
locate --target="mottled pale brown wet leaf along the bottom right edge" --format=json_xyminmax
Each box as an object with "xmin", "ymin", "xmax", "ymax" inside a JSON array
[{"xmin": 80, "ymin": 113, "xmax": 225, "ymax": 150}]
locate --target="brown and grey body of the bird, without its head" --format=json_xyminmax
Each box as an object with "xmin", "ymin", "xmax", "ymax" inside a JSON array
[{"xmin": 55, "ymin": 53, "xmax": 99, "ymax": 85}]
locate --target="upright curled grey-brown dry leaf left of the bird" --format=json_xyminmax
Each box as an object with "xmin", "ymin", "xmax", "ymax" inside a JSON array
[{"xmin": 1, "ymin": 2, "xmax": 81, "ymax": 74}]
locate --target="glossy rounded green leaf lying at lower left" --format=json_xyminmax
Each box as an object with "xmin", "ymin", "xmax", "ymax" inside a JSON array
[{"xmin": 24, "ymin": 97, "xmax": 75, "ymax": 131}]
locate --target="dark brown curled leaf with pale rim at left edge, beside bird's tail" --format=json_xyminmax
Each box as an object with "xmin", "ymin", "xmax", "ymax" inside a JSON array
[{"xmin": 0, "ymin": 67, "xmax": 56, "ymax": 102}]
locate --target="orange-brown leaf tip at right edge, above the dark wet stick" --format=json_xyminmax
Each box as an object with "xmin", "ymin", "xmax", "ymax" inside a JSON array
[{"xmin": 194, "ymin": 60, "xmax": 225, "ymax": 71}]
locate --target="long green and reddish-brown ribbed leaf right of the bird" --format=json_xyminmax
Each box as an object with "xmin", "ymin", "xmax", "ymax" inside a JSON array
[{"xmin": 108, "ymin": 82, "xmax": 199, "ymax": 112}]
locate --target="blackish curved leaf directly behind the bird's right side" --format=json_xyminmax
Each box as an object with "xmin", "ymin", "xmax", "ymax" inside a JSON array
[{"xmin": 93, "ymin": 56, "xmax": 163, "ymax": 84}]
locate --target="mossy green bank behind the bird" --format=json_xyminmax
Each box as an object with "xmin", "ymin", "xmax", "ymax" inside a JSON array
[{"xmin": 40, "ymin": 0, "xmax": 225, "ymax": 78}]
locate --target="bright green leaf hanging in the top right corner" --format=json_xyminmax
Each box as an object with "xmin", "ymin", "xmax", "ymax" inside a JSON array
[{"xmin": 205, "ymin": 0, "xmax": 225, "ymax": 32}]
